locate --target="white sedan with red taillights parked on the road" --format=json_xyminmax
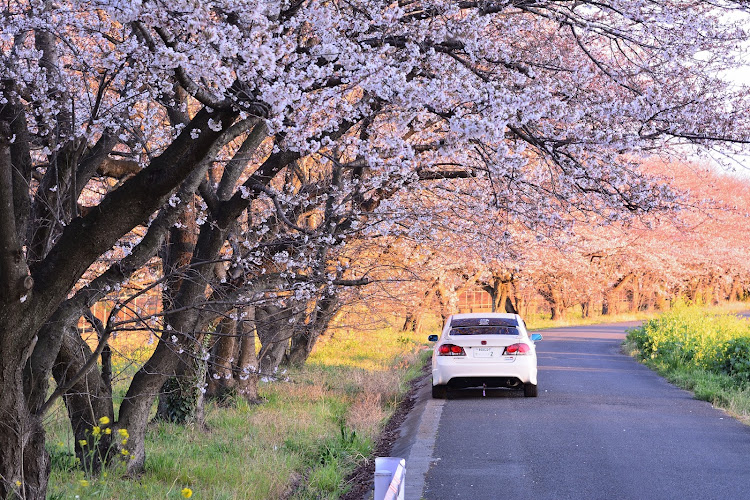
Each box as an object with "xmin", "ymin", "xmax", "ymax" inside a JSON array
[{"xmin": 429, "ymin": 313, "xmax": 542, "ymax": 398}]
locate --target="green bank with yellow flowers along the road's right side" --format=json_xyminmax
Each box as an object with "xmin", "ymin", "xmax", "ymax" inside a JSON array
[{"xmin": 625, "ymin": 305, "xmax": 750, "ymax": 424}]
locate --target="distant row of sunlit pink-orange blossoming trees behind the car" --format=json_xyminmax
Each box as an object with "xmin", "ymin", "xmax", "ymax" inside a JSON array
[{"xmin": 368, "ymin": 159, "xmax": 750, "ymax": 329}]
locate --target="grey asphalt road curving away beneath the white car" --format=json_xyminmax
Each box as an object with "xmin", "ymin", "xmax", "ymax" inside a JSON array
[{"xmin": 418, "ymin": 325, "xmax": 750, "ymax": 500}]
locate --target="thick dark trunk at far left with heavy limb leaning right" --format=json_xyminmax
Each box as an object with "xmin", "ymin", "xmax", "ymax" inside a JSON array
[{"xmin": 0, "ymin": 104, "xmax": 241, "ymax": 488}]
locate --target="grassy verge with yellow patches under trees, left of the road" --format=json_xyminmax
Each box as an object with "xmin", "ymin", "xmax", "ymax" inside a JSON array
[{"xmin": 46, "ymin": 314, "xmax": 437, "ymax": 500}]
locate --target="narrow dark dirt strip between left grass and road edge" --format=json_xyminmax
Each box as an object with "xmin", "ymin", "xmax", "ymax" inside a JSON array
[{"xmin": 339, "ymin": 359, "xmax": 431, "ymax": 500}]
